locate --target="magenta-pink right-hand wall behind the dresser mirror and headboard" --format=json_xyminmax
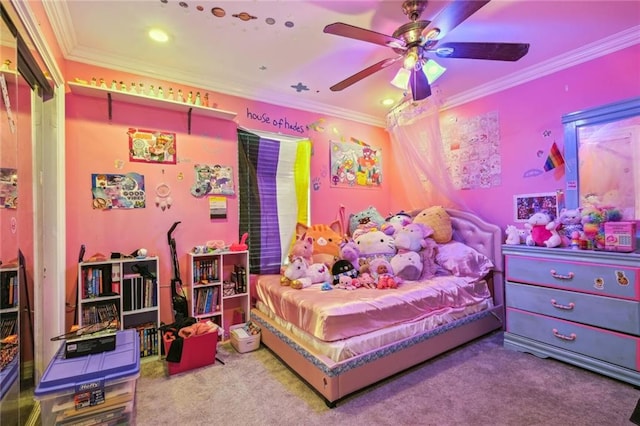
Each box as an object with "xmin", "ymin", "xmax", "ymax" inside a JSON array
[{"xmin": 392, "ymin": 45, "xmax": 640, "ymax": 229}]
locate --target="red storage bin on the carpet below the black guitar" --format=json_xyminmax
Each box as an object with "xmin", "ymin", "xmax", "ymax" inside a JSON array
[{"xmin": 162, "ymin": 329, "xmax": 218, "ymax": 375}]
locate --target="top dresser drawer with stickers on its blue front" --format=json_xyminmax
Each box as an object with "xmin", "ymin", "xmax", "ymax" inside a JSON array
[{"xmin": 505, "ymin": 255, "xmax": 640, "ymax": 300}]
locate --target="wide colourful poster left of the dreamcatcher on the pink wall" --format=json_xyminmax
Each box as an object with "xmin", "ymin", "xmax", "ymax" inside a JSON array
[{"xmin": 91, "ymin": 173, "xmax": 146, "ymax": 210}]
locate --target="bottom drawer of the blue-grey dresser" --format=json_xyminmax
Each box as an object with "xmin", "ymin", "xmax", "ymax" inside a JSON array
[{"xmin": 507, "ymin": 308, "xmax": 640, "ymax": 371}]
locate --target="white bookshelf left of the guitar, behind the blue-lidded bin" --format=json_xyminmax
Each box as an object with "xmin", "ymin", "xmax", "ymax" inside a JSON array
[{"xmin": 77, "ymin": 257, "xmax": 161, "ymax": 357}]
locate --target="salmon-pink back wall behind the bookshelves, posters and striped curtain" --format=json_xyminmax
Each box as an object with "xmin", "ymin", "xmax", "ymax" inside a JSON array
[{"xmin": 66, "ymin": 62, "xmax": 392, "ymax": 324}]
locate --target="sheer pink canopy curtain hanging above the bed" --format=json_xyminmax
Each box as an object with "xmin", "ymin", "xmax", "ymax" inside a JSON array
[{"xmin": 387, "ymin": 95, "xmax": 469, "ymax": 210}]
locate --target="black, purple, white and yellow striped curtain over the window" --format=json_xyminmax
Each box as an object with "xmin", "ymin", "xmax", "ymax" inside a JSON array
[{"xmin": 238, "ymin": 129, "xmax": 311, "ymax": 274}]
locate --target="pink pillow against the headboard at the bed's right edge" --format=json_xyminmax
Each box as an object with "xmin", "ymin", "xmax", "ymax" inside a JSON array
[{"xmin": 436, "ymin": 241, "xmax": 494, "ymax": 279}]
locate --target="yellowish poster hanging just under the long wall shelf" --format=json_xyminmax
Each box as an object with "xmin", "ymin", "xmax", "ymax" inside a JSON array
[{"xmin": 127, "ymin": 128, "xmax": 176, "ymax": 164}]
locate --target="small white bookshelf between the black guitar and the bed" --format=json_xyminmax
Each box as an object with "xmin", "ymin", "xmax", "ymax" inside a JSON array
[{"xmin": 188, "ymin": 251, "xmax": 251, "ymax": 339}]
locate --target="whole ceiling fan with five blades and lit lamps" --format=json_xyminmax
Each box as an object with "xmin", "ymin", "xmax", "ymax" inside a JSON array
[{"xmin": 324, "ymin": 0, "xmax": 529, "ymax": 101}]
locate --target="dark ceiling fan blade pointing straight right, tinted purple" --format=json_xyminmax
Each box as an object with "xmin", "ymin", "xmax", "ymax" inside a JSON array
[{"xmin": 432, "ymin": 42, "xmax": 529, "ymax": 61}]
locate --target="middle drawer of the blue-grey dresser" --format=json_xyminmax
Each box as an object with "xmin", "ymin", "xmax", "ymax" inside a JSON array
[{"xmin": 505, "ymin": 282, "xmax": 640, "ymax": 336}]
